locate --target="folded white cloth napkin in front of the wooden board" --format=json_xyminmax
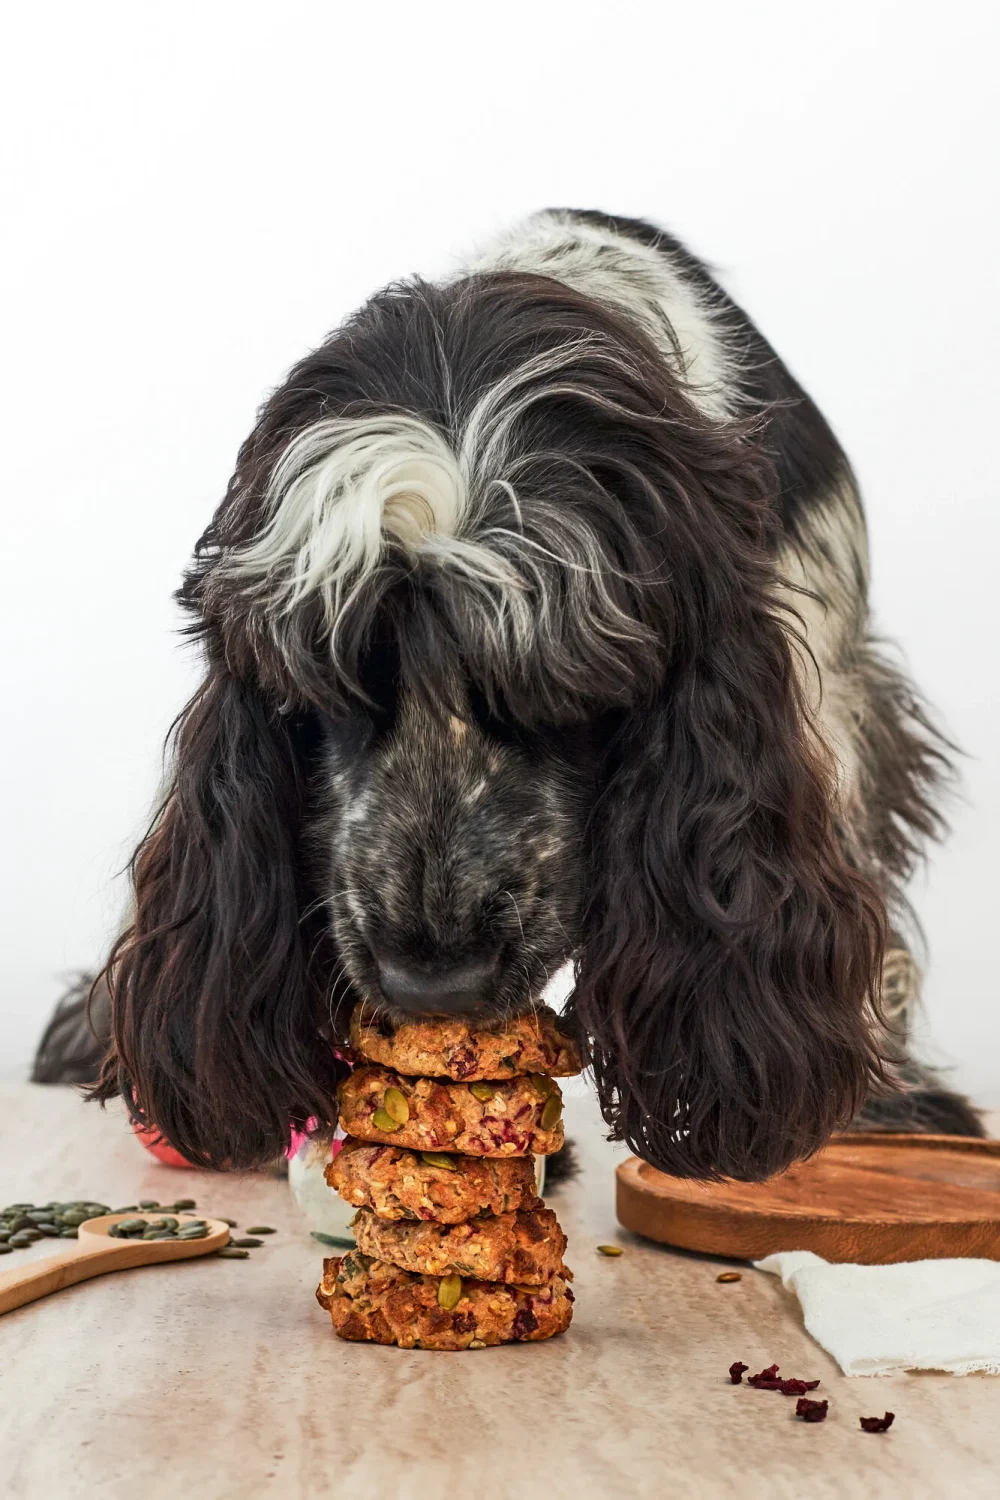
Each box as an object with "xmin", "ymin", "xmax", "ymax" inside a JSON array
[{"xmin": 754, "ymin": 1250, "xmax": 1000, "ymax": 1376}]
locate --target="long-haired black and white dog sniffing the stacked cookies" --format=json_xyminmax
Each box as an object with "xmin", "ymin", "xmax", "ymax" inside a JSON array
[{"xmin": 37, "ymin": 212, "xmax": 978, "ymax": 1179}]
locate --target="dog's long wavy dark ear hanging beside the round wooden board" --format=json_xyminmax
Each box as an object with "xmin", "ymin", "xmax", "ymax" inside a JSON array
[{"xmin": 573, "ymin": 567, "xmax": 883, "ymax": 1181}]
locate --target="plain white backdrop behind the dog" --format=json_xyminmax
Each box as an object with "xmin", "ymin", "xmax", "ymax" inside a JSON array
[{"xmin": 0, "ymin": 0, "xmax": 1000, "ymax": 1104}]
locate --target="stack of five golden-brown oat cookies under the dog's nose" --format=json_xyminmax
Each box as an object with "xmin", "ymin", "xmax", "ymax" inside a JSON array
[{"xmin": 316, "ymin": 1008, "xmax": 580, "ymax": 1349}]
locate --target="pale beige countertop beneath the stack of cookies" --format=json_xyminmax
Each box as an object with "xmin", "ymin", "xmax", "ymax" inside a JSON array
[{"xmin": 0, "ymin": 1083, "xmax": 1000, "ymax": 1500}]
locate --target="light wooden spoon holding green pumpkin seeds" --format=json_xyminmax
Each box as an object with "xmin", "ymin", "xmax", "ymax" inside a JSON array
[{"xmin": 0, "ymin": 1211, "xmax": 229, "ymax": 1314}]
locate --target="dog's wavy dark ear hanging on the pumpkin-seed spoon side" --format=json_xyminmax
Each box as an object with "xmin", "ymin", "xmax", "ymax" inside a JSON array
[{"xmin": 93, "ymin": 669, "xmax": 347, "ymax": 1169}]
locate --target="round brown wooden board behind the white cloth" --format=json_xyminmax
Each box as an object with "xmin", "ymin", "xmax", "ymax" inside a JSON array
[{"xmin": 616, "ymin": 1134, "xmax": 1000, "ymax": 1266}]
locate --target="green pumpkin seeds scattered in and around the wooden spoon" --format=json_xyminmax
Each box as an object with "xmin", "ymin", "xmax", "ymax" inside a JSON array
[{"xmin": 0, "ymin": 1199, "xmax": 274, "ymax": 1260}]
